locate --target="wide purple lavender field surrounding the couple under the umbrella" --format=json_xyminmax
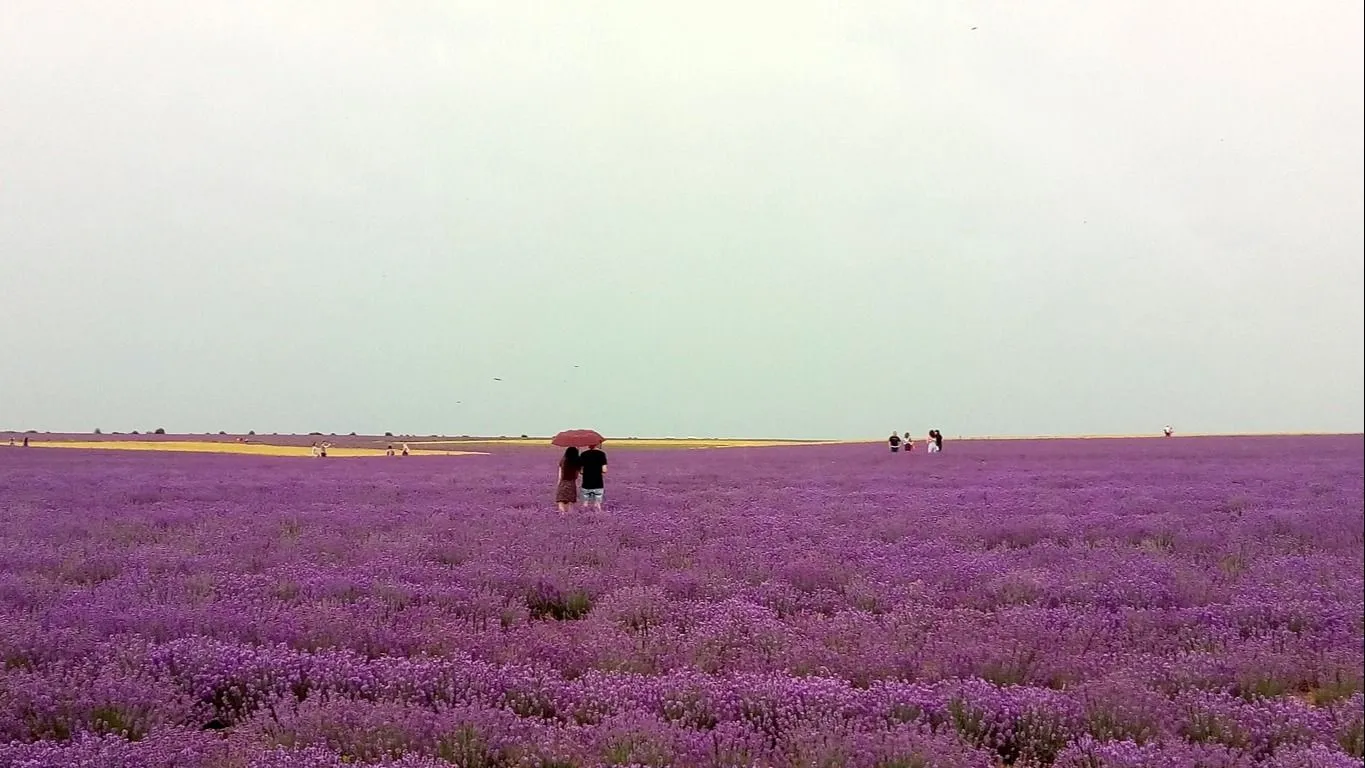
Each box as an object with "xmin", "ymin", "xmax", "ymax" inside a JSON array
[{"xmin": 0, "ymin": 435, "xmax": 1365, "ymax": 768}]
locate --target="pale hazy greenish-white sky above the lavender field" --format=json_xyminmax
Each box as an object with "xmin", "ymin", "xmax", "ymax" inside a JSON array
[{"xmin": 0, "ymin": 0, "xmax": 1365, "ymax": 438}]
